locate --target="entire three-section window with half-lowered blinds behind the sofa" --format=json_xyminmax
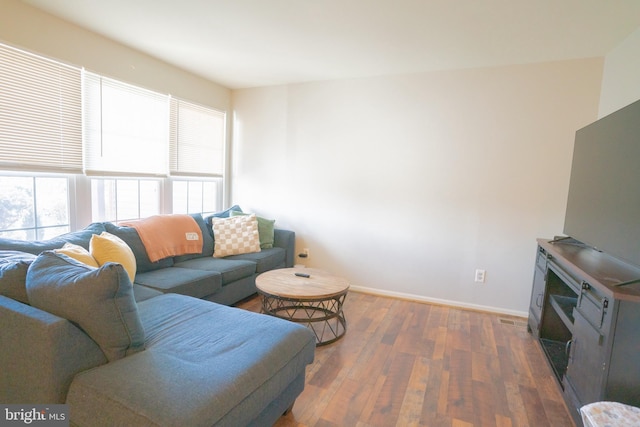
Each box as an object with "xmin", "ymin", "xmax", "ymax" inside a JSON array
[{"xmin": 0, "ymin": 43, "xmax": 227, "ymax": 240}]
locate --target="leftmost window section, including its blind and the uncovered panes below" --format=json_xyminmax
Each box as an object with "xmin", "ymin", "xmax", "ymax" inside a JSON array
[{"xmin": 0, "ymin": 44, "xmax": 77, "ymax": 240}]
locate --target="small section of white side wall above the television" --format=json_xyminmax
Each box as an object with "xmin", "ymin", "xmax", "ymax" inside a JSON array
[{"xmin": 598, "ymin": 28, "xmax": 640, "ymax": 117}]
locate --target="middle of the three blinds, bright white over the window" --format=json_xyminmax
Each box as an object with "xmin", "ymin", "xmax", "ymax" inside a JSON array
[{"xmin": 84, "ymin": 72, "xmax": 169, "ymax": 176}]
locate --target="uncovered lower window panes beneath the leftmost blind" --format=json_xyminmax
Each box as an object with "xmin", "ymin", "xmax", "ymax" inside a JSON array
[{"xmin": 0, "ymin": 175, "xmax": 70, "ymax": 240}]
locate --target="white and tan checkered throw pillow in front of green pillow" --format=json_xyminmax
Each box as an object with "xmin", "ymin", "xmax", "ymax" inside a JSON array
[{"xmin": 211, "ymin": 214, "xmax": 260, "ymax": 258}]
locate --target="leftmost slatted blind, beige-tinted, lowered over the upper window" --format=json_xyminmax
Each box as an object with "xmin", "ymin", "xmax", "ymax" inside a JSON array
[{"xmin": 0, "ymin": 44, "xmax": 82, "ymax": 173}]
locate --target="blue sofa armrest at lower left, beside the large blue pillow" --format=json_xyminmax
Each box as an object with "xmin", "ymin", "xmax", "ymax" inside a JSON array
[{"xmin": 0, "ymin": 296, "xmax": 107, "ymax": 404}]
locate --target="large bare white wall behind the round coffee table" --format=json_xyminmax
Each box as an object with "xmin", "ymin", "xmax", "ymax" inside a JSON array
[{"xmin": 232, "ymin": 59, "xmax": 602, "ymax": 314}]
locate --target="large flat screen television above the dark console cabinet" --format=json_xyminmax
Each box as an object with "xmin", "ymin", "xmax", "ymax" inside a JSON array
[{"xmin": 563, "ymin": 101, "xmax": 640, "ymax": 266}]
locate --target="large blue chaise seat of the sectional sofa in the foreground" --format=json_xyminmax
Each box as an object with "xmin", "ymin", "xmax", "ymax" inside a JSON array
[{"xmin": 67, "ymin": 294, "xmax": 315, "ymax": 426}]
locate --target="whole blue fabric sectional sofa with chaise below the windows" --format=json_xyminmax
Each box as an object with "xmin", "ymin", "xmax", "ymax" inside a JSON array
[{"xmin": 0, "ymin": 215, "xmax": 315, "ymax": 426}]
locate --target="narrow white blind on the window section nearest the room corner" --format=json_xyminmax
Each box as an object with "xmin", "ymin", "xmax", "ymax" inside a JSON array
[{"xmin": 169, "ymin": 98, "xmax": 225, "ymax": 177}]
